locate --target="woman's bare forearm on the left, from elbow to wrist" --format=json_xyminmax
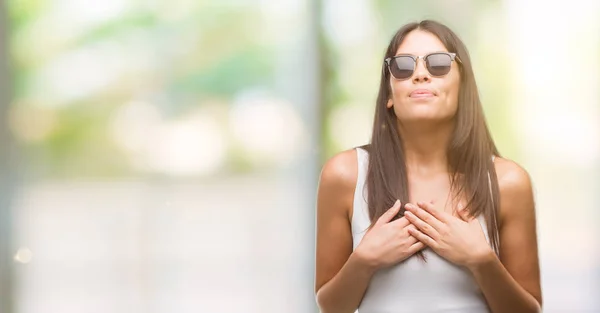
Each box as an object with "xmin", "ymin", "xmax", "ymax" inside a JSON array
[{"xmin": 317, "ymin": 254, "xmax": 375, "ymax": 313}]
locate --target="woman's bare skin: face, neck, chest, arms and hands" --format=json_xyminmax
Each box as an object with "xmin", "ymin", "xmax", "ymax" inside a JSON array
[{"xmin": 315, "ymin": 30, "xmax": 542, "ymax": 313}]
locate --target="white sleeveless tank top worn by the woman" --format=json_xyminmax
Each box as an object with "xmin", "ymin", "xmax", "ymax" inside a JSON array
[{"xmin": 351, "ymin": 148, "xmax": 490, "ymax": 313}]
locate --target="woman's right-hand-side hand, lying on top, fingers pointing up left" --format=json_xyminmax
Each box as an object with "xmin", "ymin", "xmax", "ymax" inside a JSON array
[{"xmin": 404, "ymin": 202, "xmax": 494, "ymax": 267}]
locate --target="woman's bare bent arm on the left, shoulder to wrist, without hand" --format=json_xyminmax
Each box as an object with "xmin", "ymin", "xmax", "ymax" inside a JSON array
[{"xmin": 315, "ymin": 150, "xmax": 374, "ymax": 313}]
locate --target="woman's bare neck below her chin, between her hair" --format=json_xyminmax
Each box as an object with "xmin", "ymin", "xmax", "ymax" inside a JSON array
[{"xmin": 398, "ymin": 122, "xmax": 454, "ymax": 176}]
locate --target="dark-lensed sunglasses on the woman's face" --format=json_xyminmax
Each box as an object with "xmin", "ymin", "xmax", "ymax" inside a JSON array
[{"xmin": 385, "ymin": 52, "xmax": 460, "ymax": 79}]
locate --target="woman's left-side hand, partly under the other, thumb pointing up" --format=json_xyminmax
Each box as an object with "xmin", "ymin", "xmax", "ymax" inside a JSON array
[{"xmin": 354, "ymin": 200, "xmax": 425, "ymax": 270}]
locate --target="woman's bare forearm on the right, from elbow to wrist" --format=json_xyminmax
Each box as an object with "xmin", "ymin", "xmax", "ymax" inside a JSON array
[{"xmin": 468, "ymin": 252, "xmax": 541, "ymax": 313}]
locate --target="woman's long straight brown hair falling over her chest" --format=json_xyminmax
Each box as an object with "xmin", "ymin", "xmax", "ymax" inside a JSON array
[{"xmin": 364, "ymin": 20, "xmax": 500, "ymax": 252}]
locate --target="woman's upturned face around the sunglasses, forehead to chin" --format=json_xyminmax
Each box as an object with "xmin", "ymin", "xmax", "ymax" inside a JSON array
[{"xmin": 387, "ymin": 29, "xmax": 460, "ymax": 122}]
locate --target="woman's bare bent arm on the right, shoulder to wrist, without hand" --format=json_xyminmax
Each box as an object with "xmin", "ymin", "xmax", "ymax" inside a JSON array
[{"xmin": 468, "ymin": 158, "xmax": 542, "ymax": 313}]
